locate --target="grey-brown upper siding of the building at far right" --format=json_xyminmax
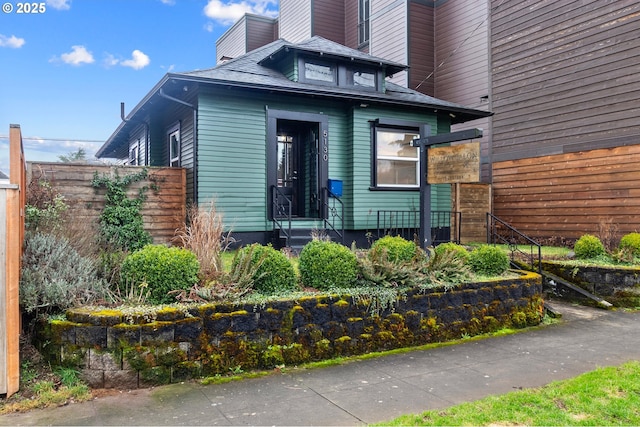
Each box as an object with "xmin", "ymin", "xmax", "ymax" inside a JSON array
[{"xmin": 491, "ymin": 1, "xmax": 640, "ymax": 162}]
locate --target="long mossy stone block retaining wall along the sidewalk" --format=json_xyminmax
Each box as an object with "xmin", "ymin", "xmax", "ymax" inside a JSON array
[{"xmin": 41, "ymin": 272, "xmax": 543, "ymax": 388}]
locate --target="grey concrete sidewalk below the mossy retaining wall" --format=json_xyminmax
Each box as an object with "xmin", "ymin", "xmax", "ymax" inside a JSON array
[{"xmin": 0, "ymin": 303, "xmax": 640, "ymax": 426}]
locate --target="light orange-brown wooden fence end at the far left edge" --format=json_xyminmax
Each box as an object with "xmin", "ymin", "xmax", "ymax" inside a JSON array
[{"xmin": 0, "ymin": 125, "xmax": 26, "ymax": 397}]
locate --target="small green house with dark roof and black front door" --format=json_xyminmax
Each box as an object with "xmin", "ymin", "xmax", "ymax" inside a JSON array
[{"xmin": 97, "ymin": 37, "xmax": 490, "ymax": 246}]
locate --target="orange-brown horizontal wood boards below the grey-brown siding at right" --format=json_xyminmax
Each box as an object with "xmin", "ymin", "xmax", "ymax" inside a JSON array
[{"xmin": 493, "ymin": 145, "xmax": 640, "ymax": 239}]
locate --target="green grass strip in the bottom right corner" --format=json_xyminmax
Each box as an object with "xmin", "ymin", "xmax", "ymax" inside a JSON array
[{"xmin": 380, "ymin": 361, "xmax": 640, "ymax": 426}]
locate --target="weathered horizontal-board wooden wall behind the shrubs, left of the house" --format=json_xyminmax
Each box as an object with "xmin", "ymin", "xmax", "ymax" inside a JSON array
[{"xmin": 28, "ymin": 162, "xmax": 186, "ymax": 243}]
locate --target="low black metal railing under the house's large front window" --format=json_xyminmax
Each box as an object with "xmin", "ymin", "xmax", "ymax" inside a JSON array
[{"xmin": 377, "ymin": 210, "xmax": 462, "ymax": 245}]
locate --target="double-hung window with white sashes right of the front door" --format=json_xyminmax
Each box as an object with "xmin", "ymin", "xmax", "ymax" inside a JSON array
[{"xmin": 373, "ymin": 126, "xmax": 420, "ymax": 188}]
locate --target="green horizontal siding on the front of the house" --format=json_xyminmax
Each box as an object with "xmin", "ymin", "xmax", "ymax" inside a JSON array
[{"xmin": 198, "ymin": 87, "xmax": 451, "ymax": 232}]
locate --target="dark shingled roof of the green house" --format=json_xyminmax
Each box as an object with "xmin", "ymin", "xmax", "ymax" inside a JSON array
[{"xmin": 96, "ymin": 36, "xmax": 491, "ymax": 157}]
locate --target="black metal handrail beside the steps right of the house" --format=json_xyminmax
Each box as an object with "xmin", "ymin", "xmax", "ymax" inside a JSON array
[{"xmin": 487, "ymin": 212, "xmax": 542, "ymax": 274}]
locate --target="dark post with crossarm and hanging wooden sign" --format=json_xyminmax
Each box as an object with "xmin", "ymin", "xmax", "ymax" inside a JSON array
[{"xmin": 411, "ymin": 125, "xmax": 482, "ymax": 249}]
